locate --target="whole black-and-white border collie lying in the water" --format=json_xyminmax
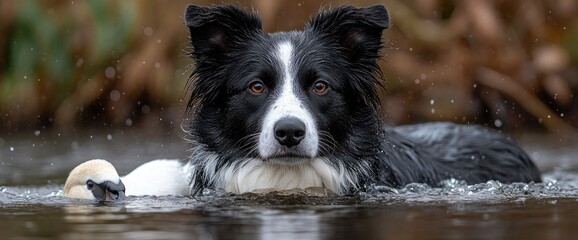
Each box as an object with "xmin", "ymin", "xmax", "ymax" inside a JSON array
[{"xmin": 185, "ymin": 5, "xmax": 541, "ymax": 195}]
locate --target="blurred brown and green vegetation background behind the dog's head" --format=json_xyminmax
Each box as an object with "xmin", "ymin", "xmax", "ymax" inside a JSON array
[{"xmin": 0, "ymin": 0, "xmax": 578, "ymax": 136}]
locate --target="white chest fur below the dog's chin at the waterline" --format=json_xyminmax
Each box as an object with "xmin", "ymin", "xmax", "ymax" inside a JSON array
[{"xmin": 191, "ymin": 148, "xmax": 358, "ymax": 194}]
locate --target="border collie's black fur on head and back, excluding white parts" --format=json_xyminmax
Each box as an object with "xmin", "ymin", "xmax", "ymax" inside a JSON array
[{"xmin": 185, "ymin": 6, "xmax": 540, "ymax": 193}]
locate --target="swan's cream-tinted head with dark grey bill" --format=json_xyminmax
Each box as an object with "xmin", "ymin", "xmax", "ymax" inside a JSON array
[{"xmin": 64, "ymin": 159, "xmax": 125, "ymax": 201}]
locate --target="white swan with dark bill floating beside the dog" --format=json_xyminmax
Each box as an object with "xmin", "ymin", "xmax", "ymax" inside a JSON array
[{"xmin": 64, "ymin": 159, "xmax": 189, "ymax": 201}]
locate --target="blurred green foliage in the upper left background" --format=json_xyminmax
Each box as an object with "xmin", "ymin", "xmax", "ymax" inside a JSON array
[{"xmin": 0, "ymin": 0, "xmax": 136, "ymax": 103}]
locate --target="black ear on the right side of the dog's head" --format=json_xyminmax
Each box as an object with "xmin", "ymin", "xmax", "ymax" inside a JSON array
[{"xmin": 306, "ymin": 5, "xmax": 389, "ymax": 61}]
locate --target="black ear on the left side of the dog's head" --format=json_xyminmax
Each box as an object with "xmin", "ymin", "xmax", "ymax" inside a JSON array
[{"xmin": 185, "ymin": 5, "xmax": 262, "ymax": 60}]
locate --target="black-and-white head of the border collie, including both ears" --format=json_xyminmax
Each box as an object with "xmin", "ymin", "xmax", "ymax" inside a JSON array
[{"xmin": 185, "ymin": 5, "xmax": 389, "ymax": 163}]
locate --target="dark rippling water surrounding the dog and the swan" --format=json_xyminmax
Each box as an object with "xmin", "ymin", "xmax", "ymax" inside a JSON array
[{"xmin": 0, "ymin": 132, "xmax": 578, "ymax": 239}]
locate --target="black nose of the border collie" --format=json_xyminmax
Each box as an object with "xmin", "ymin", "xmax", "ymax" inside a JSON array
[{"xmin": 273, "ymin": 118, "xmax": 305, "ymax": 147}]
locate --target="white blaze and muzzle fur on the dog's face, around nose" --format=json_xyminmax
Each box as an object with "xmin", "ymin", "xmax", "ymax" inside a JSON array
[{"xmin": 259, "ymin": 42, "xmax": 319, "ymax": 158}]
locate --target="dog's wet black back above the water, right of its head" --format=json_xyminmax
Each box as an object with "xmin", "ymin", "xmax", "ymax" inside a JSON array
[{"xmin": 374, "ymin": 123, "xmax": 541, "ymax": 186}]
